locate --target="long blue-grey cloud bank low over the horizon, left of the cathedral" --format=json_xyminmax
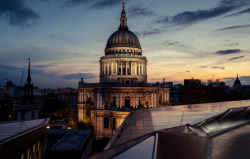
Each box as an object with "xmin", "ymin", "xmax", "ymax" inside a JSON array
[{"xmin": 0, "ymin": 65, "xmax": 96, "ymax": 88}]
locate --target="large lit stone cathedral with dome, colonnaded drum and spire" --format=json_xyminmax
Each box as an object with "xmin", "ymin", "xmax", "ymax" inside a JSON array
[{"xmin": 78, "ymin": 3, "xmax": 170, "ymax": 139}]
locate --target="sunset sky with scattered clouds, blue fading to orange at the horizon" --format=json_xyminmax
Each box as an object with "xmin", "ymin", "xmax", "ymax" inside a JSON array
[{"xmin": 0, "ymin": 0, "xmax": 250, "ymax": 88}]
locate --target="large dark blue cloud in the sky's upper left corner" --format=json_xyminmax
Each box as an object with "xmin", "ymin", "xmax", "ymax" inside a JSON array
[{"xmin": 0, "ymin": 0, "xmax": 40, "ymax": 26}]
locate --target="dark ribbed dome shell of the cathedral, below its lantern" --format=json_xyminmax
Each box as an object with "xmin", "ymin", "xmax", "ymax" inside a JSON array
[{"xmin": 106, "ymin": 28, "xmax": 141, "ymax": 49}]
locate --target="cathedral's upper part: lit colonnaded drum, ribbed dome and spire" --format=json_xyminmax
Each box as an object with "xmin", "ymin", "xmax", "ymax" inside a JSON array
[{"xmin": 100, "ymin": 3, "xmax": 147, "ymax": 83}]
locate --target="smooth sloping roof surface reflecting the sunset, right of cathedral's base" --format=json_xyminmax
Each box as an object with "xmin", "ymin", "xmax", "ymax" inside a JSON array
[{"xmin": 106, "ymin": 100, "xmax": 250, "ymax": 148}]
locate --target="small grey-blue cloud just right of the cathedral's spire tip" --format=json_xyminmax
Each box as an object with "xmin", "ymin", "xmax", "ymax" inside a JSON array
[{"xmin": 128, "ymin": 5, "xmax": 157, "ymax": 17}]
